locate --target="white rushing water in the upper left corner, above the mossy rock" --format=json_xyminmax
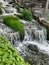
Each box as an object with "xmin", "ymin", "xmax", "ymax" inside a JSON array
[{"xmin": 0, "ymin": 0, "xmax": 17, "ymax": 16}]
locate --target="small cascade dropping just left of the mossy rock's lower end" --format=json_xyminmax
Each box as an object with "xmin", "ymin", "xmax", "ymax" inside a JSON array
[{"xmin": 10, "ymin": 32, "xmax": 20, "ymax": 47}]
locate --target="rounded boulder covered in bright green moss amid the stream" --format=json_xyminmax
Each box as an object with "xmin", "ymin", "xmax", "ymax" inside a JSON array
[{"xmin": 3, "ymin": 16, "xmax": 25, "ymax": 41}]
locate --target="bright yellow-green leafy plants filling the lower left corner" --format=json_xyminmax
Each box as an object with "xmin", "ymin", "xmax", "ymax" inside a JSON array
[{"xmin": 0, "ymin": 35, "xmax": 30, "ymax": 65}]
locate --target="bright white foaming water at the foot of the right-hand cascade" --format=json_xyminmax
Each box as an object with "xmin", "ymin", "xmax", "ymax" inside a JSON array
[{"xmin": 28, "ymin": 41, "xmax": 49, "ymax": 55}]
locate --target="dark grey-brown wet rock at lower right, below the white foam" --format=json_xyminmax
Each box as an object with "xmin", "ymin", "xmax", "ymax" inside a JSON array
[{"xmin": 23, "ymin": 45, "xmax": 49, "ymax": 65}]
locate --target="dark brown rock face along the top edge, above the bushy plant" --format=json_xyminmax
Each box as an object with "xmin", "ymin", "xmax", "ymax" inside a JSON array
[{"xmin": 15, "ymin": 0, "xmax": 46, "ymax": 7}]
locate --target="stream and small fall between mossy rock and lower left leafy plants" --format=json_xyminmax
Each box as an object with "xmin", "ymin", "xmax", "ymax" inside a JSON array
[{"xmin": 0, "ymin": 23, "xmax": 20, "ymax": 45}]
